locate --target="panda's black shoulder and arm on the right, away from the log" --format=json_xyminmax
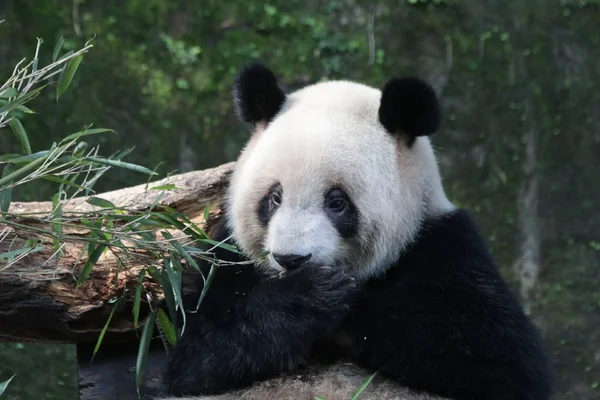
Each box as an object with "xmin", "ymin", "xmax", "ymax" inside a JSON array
[{"xmin": 343, "ymin": 211, "xmax": 552, "ymax": 400}]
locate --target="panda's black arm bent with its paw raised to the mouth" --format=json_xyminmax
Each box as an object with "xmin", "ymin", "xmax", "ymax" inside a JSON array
[{"xmin": 166, "ymin": 252, "xmax": 354, "ymax": 395}]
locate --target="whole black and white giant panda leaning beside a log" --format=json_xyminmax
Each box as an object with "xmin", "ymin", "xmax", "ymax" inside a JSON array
[{"xmin": 158, "ymin": 64, "xmax": 553, "ymax": 400}]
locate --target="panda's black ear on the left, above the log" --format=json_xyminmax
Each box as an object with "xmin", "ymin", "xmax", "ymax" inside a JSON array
[{"xmin": 233, "ymin": 64, "xmax": 286, "ymax": 124}]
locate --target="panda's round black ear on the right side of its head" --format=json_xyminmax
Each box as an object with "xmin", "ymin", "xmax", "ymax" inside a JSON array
[{"xmin": 379, "ymin": 77, "xmax": 442, "ymax": 138}]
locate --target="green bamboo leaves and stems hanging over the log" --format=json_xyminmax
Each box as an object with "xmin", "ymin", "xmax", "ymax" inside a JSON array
[{"xmin": 0, "ymin": 28, "xmax": 244, "ymax": 392}]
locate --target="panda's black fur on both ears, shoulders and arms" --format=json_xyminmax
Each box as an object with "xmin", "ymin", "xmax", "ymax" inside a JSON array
[{"xmin": 166, "ymin": 65, "xmax": 552, "ymax": 400}]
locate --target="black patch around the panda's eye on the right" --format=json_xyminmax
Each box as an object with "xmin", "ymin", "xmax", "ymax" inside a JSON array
[{"xmin": 324, "ymin": 187, "xmax": 359, "ymax": 238}]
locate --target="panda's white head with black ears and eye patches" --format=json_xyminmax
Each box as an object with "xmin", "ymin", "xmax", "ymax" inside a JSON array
[{"xmin": 227, "ymin": 64, "xmax": 452, "ymax": 279}]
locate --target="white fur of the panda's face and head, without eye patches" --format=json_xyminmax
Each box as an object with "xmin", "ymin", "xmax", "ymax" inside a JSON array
[{"xmin": 227, "ymin": 81, "xmax": 453, "ymax": 279}]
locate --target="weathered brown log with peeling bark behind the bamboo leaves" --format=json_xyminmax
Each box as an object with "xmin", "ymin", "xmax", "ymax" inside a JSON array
[{"xmin": 0, "ymin": 163, "xmax": 234, "ymax": 343}]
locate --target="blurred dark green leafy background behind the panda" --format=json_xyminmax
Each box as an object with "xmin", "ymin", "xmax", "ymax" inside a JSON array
[{"xmin": 0, "ymin": 0, "xmax": 600, "ymax": 400}]
